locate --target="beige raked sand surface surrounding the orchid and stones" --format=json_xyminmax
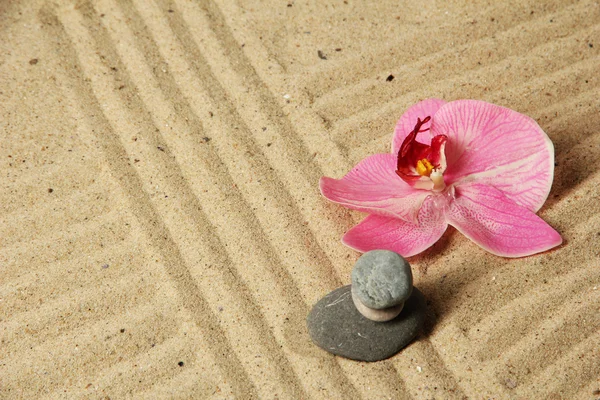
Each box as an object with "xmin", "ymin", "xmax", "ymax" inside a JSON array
[{"xmin": 0, "ymin": 0, "xmax": 600, "ymax": 399}]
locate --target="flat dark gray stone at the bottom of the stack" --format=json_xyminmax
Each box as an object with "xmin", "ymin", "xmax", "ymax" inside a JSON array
[{"xmin": 306, "ymin": 285, "xmax": 427, "ymax": 361}]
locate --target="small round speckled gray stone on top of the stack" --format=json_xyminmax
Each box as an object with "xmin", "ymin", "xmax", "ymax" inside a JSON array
[{"xmin": 352, "ymin": 250, "xmax": 412, "ymax": 310}]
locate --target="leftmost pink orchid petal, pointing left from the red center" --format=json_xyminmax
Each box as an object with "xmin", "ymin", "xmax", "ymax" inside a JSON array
[{"xmin": 320, "ymin": 154, "xmax": 430, "ymax": 221}]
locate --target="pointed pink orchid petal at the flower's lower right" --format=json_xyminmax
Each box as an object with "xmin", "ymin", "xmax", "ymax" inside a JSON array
[{"xmin": 446, "ymin": 183, "xmax": 562, "ymax": 257}]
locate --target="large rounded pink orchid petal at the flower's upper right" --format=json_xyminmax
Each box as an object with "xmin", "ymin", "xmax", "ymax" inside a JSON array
[{"xmin": 431, "ymin": 100, "xmax": 554, "ymax": 212}]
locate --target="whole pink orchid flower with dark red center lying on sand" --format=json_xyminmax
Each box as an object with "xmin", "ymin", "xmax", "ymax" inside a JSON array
[{"xmin": 320, "ymin": 99, "xmax": 562, "ymax": 257}]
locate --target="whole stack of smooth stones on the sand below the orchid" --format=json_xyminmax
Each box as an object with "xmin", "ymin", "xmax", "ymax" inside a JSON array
[{"xmin": 307, "ymin": 250, "xmax": 426, "ymax": 361}]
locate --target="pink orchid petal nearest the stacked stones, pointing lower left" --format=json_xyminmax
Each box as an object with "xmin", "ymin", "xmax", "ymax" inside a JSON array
[{"xmin": 342, "ymin": 196, "xmax": 448, "ymax": 257}]
